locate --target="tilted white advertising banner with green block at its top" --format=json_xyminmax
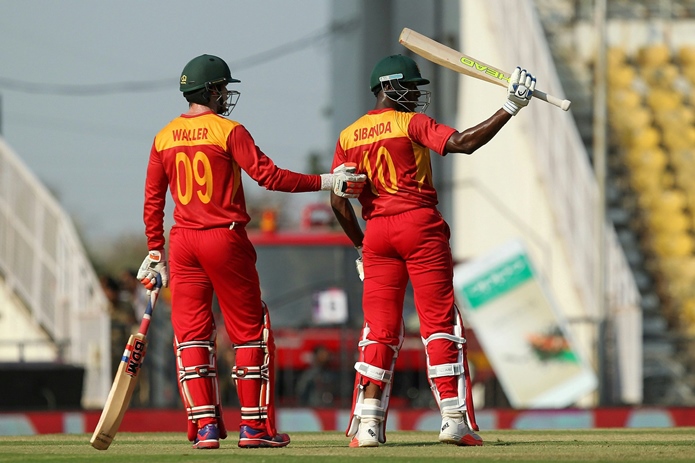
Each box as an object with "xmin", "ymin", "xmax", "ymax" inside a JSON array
[{"xmin": 454, "ymin": 241, "xmax": 598, "ymax": 408}]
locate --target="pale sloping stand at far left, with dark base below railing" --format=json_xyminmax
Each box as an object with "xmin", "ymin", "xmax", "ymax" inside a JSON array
[{"xmin": 0, "ymin": 137, "xmax": 111, "ymax": 410}]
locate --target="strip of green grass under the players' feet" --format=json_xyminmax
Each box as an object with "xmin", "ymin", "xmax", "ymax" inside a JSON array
[{"xmin": 0, "ymin": 428, "xmax": 695, "ymax": 463}]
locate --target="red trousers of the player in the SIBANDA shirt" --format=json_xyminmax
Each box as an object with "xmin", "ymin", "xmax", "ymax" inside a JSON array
[{"xmin": 362, "ymin": 208, "xmax": 458, "ymax": 398}]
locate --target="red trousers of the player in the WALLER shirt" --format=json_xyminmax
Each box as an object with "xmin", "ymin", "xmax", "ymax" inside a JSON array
[{"xmin": 169, "ymin": 226, "xmax": 272, "ymax": 428}]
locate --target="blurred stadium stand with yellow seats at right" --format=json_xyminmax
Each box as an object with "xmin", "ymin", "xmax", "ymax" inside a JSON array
[{"xmin": 536, "ymin": 0, "xmax": 695, "ymax": 404}]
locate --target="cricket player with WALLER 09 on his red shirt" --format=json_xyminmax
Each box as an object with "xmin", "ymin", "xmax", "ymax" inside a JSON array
[{"xmin": 138, "ymin": 55, "xmax": 366, "ymax": 449}]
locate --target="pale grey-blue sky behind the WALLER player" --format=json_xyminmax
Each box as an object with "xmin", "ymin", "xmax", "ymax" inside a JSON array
[{"xmin": 0, "ymin": 0, "xmax": 335, "ymax": 244}]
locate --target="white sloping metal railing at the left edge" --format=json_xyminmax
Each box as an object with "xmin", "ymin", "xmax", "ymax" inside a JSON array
[{"xmin": 0, "ymin": 138, "xmax": 111, "ymax": 407}]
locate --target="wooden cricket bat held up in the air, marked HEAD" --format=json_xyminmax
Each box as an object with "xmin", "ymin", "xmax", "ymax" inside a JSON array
[{"xmin": 398, "ymin": 27, "xmax": 572, "ymax": 111}]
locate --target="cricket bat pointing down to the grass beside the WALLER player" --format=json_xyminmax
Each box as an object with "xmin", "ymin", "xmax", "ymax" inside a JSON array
[{"xmin": 89, "ymin": 277, "xmax": 161, "ymax": 450}]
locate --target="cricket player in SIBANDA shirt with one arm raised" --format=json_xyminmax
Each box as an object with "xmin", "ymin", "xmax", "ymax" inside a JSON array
[{"xmin": 331, "ymin": 55, "xmax": 536, "ymax": 447}]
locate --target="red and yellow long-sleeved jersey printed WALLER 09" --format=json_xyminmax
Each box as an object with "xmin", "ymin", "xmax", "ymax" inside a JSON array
[{"xmin": 144, "ymin": 112, "xmax": 321, "ymax": 249}]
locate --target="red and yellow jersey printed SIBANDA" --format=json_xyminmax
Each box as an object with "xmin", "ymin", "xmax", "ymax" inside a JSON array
[{"xmin": 332, "ymin": 109, "xmax": 456, "ymax": 220}]
